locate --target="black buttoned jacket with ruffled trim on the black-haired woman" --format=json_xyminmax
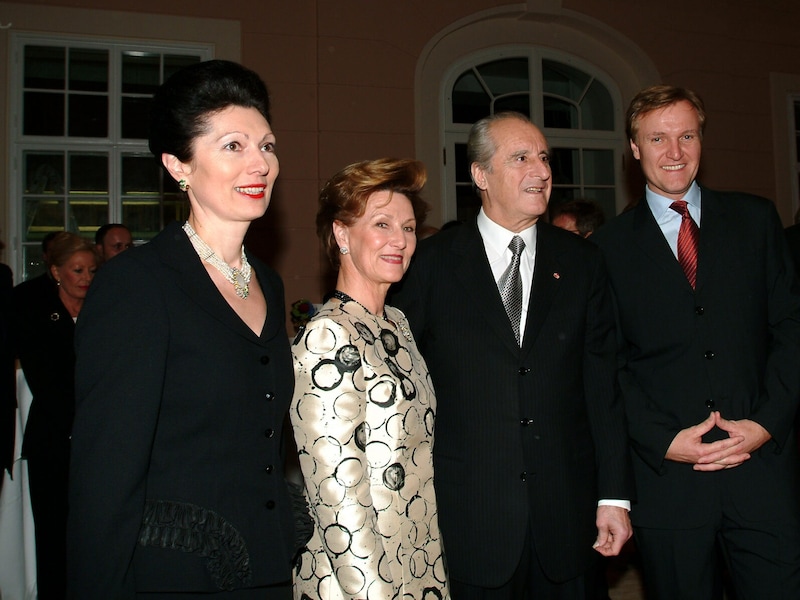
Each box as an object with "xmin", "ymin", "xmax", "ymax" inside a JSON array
[{"xmin": 68, "ymin": 224, "xmax": 294, "ymax": 600}]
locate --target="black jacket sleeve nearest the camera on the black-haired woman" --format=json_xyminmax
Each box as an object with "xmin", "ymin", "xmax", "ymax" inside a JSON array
[{"xmin": 68, "ymin": 261, "xmax": 169, "ymax": 600}]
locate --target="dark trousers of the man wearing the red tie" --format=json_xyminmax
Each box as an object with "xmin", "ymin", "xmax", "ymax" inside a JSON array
[{"xmin": 635, "ymin": 502, "xmax": 800, "ymax": 600}]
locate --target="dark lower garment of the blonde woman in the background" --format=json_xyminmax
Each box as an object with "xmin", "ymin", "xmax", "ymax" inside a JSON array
[{"xmin": 27, "ymin": 442, "xmax": 69, "ymax": 600}]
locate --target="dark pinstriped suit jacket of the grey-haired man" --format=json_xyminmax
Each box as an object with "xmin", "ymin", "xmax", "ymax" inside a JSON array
[{"xmin": 392, "ymin": 222, "xmax": 632, "ymax": 587}]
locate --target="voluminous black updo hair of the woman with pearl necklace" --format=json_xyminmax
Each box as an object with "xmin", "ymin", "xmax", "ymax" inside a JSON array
[{"xmin": 149, "ymin": 60, "xmax": 270, "ymax": 167}]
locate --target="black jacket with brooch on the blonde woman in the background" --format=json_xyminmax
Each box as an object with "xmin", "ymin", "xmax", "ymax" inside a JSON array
[{"xmin": 12, "ymin": 274, "xmax": 75, "ymax": 458}]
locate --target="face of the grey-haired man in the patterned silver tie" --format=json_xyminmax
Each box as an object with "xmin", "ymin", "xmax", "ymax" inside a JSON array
[{"xmin": 470, "ymin": 118, "xmax": 552, "ymax": 232}]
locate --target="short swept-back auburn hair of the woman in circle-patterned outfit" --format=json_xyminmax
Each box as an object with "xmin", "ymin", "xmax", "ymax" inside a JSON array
[{"xmin": 317, "ymin": 158, "xmax": 428, "ymax": 268}]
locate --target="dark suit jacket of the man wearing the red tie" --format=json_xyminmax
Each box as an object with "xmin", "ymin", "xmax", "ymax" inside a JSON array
[{"xmin": 592, "ymin": 188, "xmax": 800, "ymax": 529}]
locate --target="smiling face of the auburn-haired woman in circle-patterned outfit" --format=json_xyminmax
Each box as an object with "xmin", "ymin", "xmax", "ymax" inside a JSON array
[{"xmin": 333, "ymin": 190, "xmax": 417, "ymax": 287}]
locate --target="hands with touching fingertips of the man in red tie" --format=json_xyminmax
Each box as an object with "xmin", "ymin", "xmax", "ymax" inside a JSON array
[{"xmin": 666, "ymin": 411, "xmax": 771, "ymax": 471}]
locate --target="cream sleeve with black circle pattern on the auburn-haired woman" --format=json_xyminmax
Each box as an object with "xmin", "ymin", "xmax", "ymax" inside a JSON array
[{"xmin": 290, "ymin": 318, "xmax": 397, "ymax": 598}]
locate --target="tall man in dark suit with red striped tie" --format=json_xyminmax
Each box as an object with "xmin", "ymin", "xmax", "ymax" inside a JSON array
[{"xmin": 592, "ymin": 86, "xmax": 800, "ymax": 600}]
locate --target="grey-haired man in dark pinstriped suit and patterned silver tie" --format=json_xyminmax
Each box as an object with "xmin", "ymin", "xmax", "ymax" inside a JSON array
[{"xmin": 393, "ymin": 113, "xmax": 632, "ymax": 600}]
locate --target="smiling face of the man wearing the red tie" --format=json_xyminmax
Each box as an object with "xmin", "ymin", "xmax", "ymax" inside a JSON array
[{"xmin": 631, "ymin": 100, "xmax": 702, "ymax": 200}]
